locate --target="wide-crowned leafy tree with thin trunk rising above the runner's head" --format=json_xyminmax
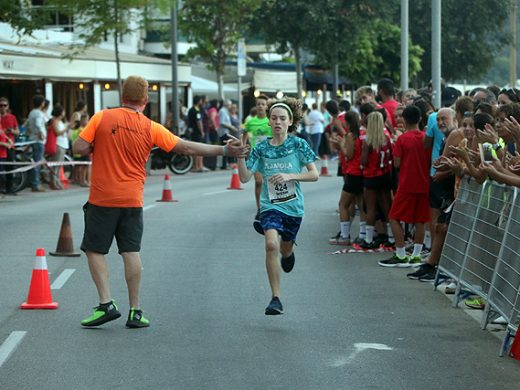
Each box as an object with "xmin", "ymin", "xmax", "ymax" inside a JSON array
[{"xmin": 252, "ymin": 0, "xmax": 410, "ymax": 92}]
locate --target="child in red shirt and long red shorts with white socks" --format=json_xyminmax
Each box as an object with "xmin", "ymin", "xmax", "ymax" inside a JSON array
[{"xmin": 379, "ymin": 105, "xmax": 431, "ymax": 267}]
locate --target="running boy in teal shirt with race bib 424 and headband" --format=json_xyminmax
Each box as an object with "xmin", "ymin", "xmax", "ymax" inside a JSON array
[{"xmin": 238, "ymin": 98, "xmax": 319, "ymax": 315}]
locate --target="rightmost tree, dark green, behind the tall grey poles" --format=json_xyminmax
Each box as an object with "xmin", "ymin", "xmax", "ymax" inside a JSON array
[{"xmin": 402, "ymin": 0, "xmax": 512, "ymax": 83}]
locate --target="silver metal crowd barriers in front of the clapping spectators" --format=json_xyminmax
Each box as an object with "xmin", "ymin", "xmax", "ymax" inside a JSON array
[{"xmin": 437, "ymin": 179, "xmax": 520, "ymax": 356}]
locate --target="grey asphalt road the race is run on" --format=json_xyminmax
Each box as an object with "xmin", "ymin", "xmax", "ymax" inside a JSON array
[{"xmin": 0, "ymin": 166, "xmax": 520, "ymax": 390}]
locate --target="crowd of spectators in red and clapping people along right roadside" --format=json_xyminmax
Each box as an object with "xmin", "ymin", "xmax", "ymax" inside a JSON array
[{"xmin": 318, "ymin": 79, "xmax": 520, "ymax": 322}]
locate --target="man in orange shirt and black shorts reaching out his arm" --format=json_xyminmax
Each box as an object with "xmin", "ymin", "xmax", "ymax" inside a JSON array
[{"xmin": 73, "ymin": 76, "xmax": 249, "ymax": 328}]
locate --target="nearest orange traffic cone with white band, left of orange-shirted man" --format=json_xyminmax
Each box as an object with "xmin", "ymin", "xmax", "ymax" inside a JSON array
[{"xmin": 20, "ymin": 248, "xmax": 58, "ymax": 309}]
